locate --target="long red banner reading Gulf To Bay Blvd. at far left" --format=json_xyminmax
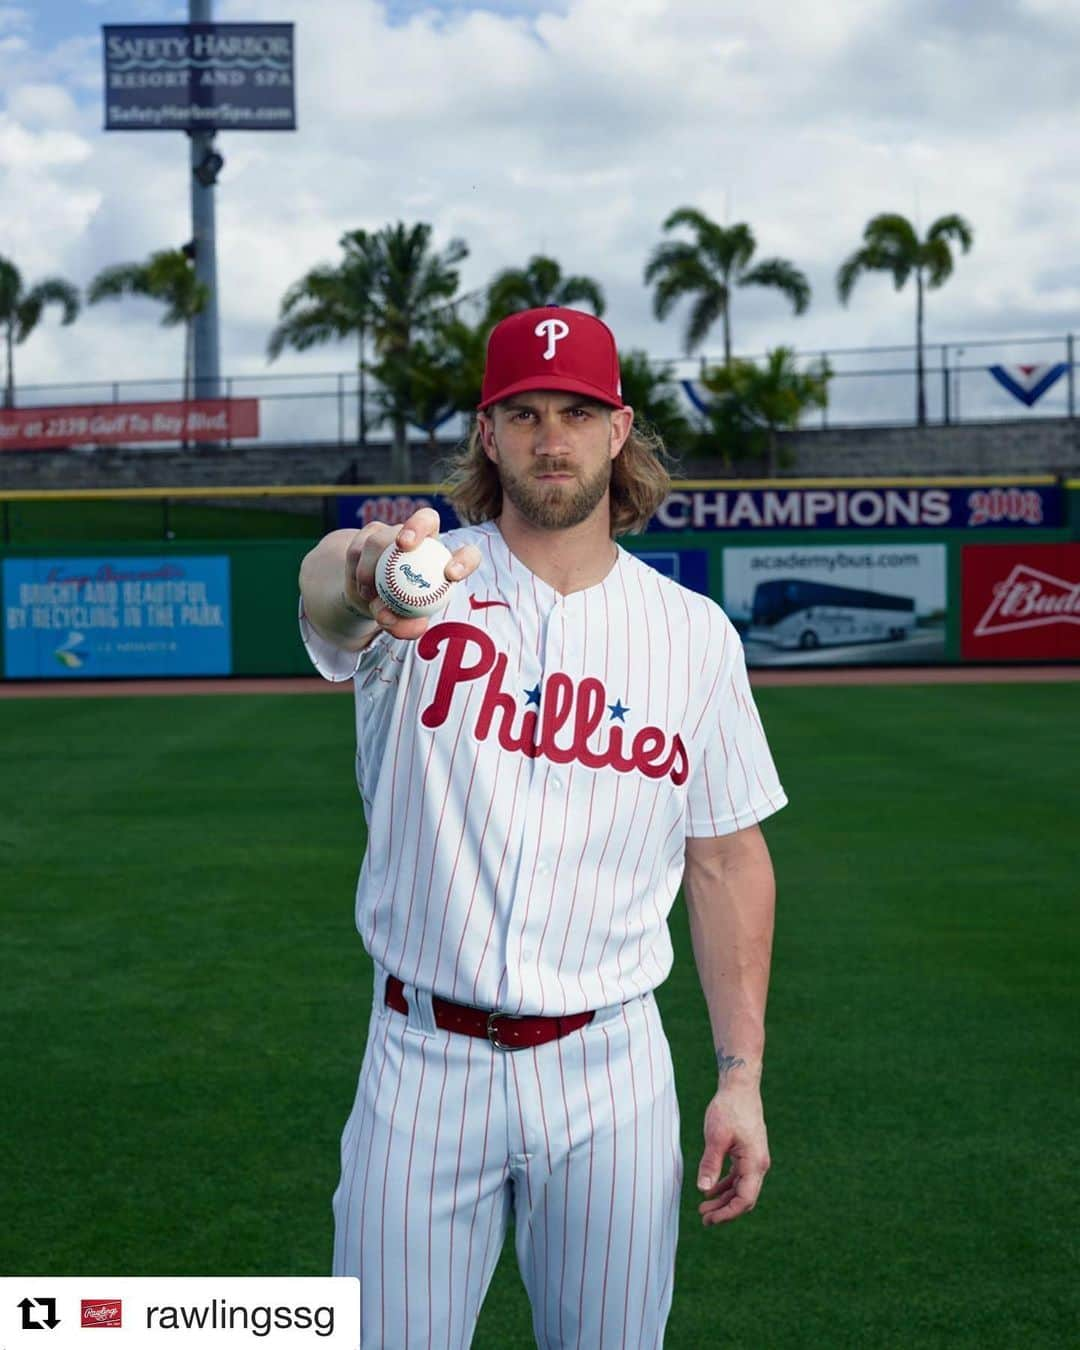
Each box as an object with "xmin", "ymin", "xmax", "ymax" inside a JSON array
[{"xmin": 0, "ymin": 398, "xmax": 259, "ymax": 450}]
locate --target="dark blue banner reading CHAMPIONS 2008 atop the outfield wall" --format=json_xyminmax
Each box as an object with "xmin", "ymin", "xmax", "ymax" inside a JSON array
[{"xmin": 648, "ymin": 483, "xmax": 1064, "ymax": 531}]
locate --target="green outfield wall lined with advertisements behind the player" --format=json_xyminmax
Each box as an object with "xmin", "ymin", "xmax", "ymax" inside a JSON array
[{"xmin": 0, "ymin": 477, "xmax": 1080, "ymax": 680}]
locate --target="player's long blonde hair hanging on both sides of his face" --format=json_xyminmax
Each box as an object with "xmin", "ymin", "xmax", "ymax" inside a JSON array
[{"xmin": 444, "ymin": 410, "xmax": 672, "ymax": 539}]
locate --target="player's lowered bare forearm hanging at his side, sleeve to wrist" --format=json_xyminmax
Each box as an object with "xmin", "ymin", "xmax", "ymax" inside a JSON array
[{"xmin": 683, "ymin": 828, "xmax": 776, "ymax": 1087}]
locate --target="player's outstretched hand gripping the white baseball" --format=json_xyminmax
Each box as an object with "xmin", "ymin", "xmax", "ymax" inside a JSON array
[{"xmin": 344, "ymin": 506, "xmax": 481, "ymax": 641}]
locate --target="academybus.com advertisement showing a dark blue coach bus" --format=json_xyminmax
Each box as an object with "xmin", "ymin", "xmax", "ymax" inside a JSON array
[{"xmin": 724, "ymin": 544, "xmax": 946, "ymax": 666}]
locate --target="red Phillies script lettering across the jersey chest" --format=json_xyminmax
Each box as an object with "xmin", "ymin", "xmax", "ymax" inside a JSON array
[{"xmin": 417, "ymin": 622, "xmax": 690, "ymax": 787}]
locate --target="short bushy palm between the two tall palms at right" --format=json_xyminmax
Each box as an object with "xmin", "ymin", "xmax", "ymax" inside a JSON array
[{"xmin": 702, "ymin": 347, "xmax": 832, "ymax": 478}]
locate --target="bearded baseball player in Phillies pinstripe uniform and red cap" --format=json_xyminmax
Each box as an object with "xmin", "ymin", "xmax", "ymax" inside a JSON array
[{"xmin": 300, "ymin": 306, "xmax": 786, "ymax": 1350}]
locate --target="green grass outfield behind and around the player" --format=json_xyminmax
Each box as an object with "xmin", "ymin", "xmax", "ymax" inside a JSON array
[{"xmin": 0, "ymin": 684, "xmax": 1080, "ymax": 1350}]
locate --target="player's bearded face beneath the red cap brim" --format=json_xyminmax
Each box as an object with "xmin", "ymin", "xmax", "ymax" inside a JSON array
[{"xmin": 479, "ymin": 390, "xmax": 633, "ymax": 529}]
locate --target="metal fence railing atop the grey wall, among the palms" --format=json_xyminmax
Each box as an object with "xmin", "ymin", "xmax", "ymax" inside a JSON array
[{"xmin": 6, "ymin": 333, "xmax": 1076, "ymax": 446}]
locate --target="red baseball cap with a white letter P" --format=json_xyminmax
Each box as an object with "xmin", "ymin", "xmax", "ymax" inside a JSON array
[{"xmin": 479, "ymin": 305, "xmax": 622, "ymax": 409}]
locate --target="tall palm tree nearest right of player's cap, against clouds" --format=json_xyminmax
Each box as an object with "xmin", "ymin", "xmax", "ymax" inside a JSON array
[{"xmin": 645, "ymin": 207, "xmax": 810, "ymax": 366}]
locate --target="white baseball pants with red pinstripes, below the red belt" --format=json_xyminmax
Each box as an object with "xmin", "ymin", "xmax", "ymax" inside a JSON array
[{"xmin": 333, "ymin": 969, "xmax": 682, "ymax": 1350}]
